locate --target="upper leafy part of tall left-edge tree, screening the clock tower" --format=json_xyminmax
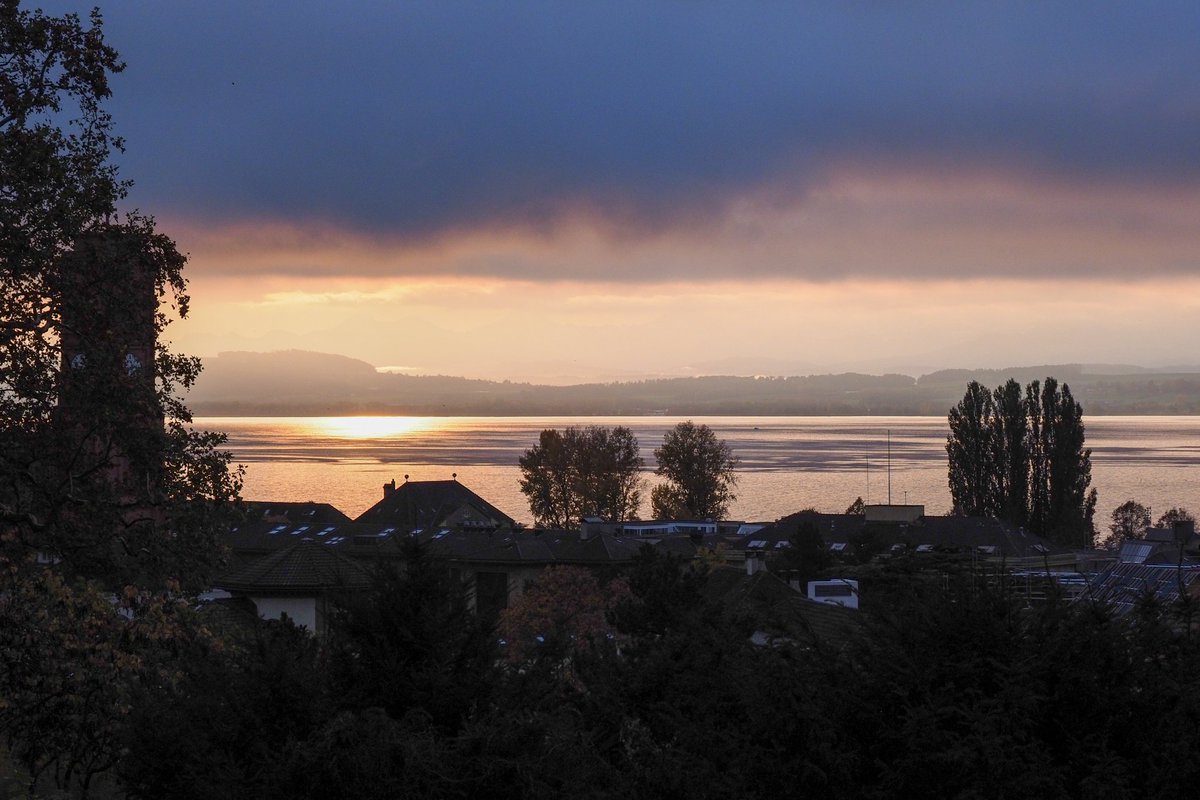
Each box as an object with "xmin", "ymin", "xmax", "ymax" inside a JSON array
[{"xmin": 0, "ymin": 0, "xmax": 239, "ymax": 587}]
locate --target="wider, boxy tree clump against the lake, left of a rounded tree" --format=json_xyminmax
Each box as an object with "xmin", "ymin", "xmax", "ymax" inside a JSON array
[{"xmin": 520, "ymin": 425, "xmax": 642, "ymax": 528}]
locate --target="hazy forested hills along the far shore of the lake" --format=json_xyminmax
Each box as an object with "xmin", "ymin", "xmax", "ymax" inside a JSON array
[{"xmin": 188, "ymin": 350, "xmax": 1200, "ymax": 416}]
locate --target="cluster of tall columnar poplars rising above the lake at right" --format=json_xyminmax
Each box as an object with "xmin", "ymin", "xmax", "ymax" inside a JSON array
[{"xmin": 946, "ymin": 378, "xmax": 1096, "ymax": 547}]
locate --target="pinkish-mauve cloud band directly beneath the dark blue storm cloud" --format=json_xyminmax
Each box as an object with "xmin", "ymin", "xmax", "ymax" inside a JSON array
[{"xmin": 168, "ymin": 164, "xmax": 1200, "ymax": 283}]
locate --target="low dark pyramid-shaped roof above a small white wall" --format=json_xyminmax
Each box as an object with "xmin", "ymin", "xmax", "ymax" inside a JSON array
[{"xmin": 214, "ymin": 539, "xmax": 371, "ymax": 594}]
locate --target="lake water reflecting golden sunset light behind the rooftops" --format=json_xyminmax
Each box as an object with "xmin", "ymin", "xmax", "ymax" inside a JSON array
[{"xmin": 196, "ymin": 416, "xmax": 1200, "ymax": 534}]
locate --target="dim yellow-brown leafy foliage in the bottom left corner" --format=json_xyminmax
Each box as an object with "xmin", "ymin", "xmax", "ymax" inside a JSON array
[{"xmin": 0, "ymin": 563, "xmax": 204, "ymax": 796}]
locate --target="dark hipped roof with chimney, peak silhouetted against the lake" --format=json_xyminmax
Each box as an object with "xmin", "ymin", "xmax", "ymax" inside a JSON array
[{"xmin": 355, "ymin": 481, "xmax": 516, "ymax": 530}]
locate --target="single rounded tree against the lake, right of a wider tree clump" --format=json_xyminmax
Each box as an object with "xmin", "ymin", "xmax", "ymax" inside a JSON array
[{"xmin": 650, "ymin": 420, "xmax": 738, "ymax": 519}]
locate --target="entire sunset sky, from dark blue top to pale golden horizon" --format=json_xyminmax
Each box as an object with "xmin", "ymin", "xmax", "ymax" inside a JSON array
[{"xmin": 44, "ymin": 0, "xmax": 1200, "ymax": 383}]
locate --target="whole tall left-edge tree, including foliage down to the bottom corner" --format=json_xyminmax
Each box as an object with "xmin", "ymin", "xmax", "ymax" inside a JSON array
[{"xmin": 0, "ymin": 10, "xmax": 239, "ymax": 795}]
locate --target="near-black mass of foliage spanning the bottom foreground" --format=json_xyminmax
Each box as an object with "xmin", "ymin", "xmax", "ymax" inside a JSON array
[{"xmin": 105, "ymin": 548, "xmax": 1200, "ymax": 799}]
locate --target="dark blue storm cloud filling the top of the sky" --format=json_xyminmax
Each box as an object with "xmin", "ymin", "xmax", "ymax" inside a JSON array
[{"xmin": 49, "ymin": 0, "xmax": 1200, "ymax": 237}]
